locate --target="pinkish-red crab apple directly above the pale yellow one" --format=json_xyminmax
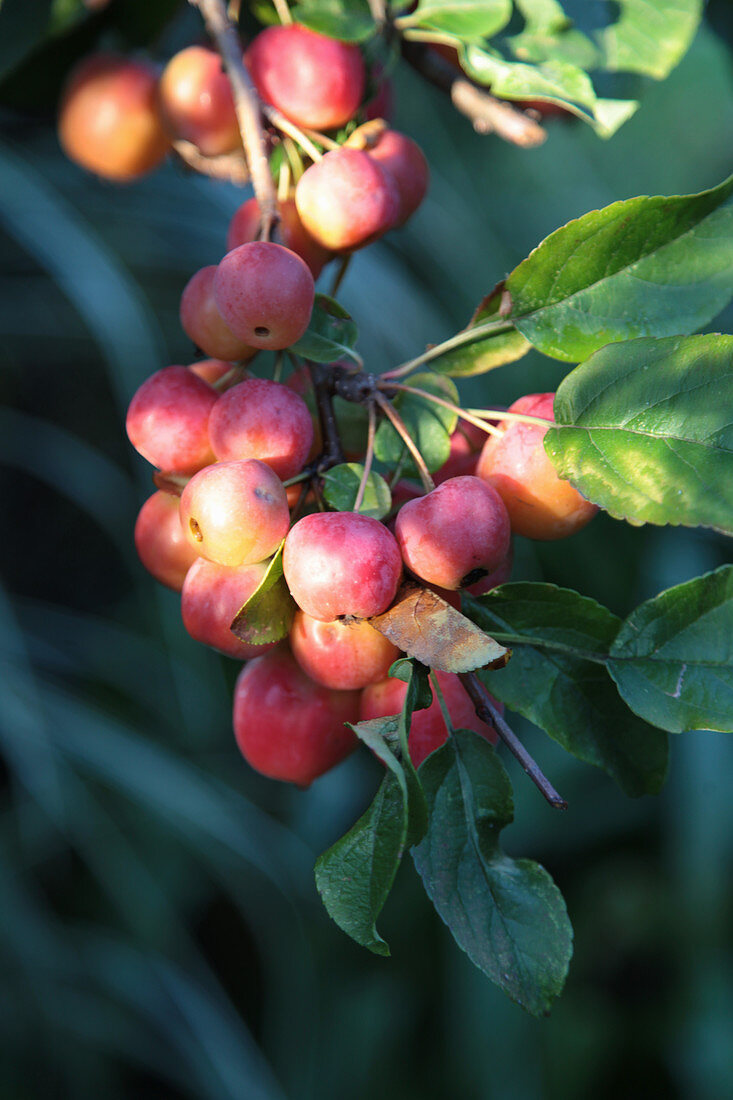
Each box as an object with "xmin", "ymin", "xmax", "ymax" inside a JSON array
[{"xmin": 209, "ymin": 378, "xmax": 314, "ymax": 481}]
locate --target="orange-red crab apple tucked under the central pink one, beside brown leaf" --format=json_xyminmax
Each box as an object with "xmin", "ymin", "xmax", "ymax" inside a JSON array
[{"xmin": 289, "ymin": 611, "xmax": 400, "ymax": 691}]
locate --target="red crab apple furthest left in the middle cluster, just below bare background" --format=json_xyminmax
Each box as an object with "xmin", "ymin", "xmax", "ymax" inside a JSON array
[{"xmin": 127, "ymin": 366, "xmax": 219, "ymax": 474}]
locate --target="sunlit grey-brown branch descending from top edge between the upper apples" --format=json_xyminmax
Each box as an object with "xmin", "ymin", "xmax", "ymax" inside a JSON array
[{"xmin": 190, "ymin": 0, "xmax": 277, "ymax": 241}]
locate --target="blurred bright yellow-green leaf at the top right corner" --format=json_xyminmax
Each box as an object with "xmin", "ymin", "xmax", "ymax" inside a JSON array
[{"xmin": 598, "ymin": 0, "xmax": 702, "ymax": 80}]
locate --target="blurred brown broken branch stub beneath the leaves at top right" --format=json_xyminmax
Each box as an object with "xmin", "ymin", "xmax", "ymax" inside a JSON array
[{"xmin": 403, "ymin": 39, "xmax": 547, "ymax": 149}]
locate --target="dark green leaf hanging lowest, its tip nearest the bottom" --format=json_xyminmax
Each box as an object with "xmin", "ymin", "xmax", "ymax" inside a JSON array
[{"xmin": 414, "ymin": 730, "xmax": 572, "ymax": 1015}]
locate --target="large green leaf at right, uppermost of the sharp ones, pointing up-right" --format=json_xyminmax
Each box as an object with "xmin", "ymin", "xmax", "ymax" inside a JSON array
[{"xmin": 506, "ymin": 177, "xmax": 733, "ymax": 362}]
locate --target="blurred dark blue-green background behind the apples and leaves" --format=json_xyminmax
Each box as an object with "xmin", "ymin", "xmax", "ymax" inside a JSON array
[{"xmin": 0, "ymin": 0, "xmax": 733, "ymax": 1100}]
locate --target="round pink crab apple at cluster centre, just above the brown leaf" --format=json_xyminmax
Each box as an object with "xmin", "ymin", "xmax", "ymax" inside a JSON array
[{"xmin": 283, "ymin": 512, "xmax": 402, "ymax": 623}]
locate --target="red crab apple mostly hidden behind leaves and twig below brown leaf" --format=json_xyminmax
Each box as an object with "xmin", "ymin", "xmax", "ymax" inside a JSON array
[{"xmin": 359, "ymin": 671, "xmax": 504, "ymax": 768}]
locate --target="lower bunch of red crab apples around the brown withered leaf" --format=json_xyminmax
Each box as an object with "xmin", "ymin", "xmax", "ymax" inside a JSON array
[{"xmin": 127, "ymin": 347, "xmax": 595, "ymax": 785}]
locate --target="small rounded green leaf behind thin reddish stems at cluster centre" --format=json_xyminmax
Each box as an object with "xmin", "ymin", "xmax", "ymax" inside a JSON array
[{"xmin": 374, "ymin": 373, "xmax": 460, "ymax": 477}]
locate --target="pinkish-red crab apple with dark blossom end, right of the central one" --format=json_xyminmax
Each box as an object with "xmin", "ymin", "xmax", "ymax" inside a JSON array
[{"xmin": 394, "ymin": 476, "xmax": 511, "ymax": 589}]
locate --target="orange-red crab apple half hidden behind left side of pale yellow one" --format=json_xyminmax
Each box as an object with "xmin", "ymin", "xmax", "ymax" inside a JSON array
[{"xmin": 134, "ymin": 492, "xmax": 196, "ymax": 592}]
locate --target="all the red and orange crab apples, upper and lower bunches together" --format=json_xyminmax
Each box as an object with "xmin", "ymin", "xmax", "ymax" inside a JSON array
[{"xmin": 59, "ymin": 17, "xmax": 595, "ymax": 785}]
